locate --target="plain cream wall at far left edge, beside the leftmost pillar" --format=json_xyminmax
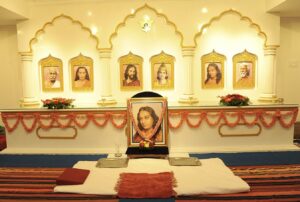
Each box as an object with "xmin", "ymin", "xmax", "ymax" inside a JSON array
[{"xmin": 0, "ymin": 25, "xmax": 22, "ymax": 108}]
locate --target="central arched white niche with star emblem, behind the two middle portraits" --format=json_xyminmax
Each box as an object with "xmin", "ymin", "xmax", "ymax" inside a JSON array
[{"xmin": 110, "ymin": 5, "xmax": 183, "ymax": 102}]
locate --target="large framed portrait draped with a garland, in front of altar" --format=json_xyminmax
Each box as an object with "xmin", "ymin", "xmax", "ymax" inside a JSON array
[{"xmin": 127, "ymin": 98, "xmax": 168, "ymax": 147}]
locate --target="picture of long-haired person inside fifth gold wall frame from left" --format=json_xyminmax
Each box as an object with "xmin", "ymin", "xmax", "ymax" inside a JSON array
[{"xmin": 204, "ymin": 63, "xmax": 222, "ymax": 86}]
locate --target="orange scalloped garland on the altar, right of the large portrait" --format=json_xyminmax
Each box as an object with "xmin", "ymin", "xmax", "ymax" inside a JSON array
[{"xmin": 168, "ymin": 108, "xmax": 298, "ymax": 129}]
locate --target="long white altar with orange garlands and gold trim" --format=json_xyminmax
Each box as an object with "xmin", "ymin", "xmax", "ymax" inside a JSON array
[{"xmin": 1, "ymin": 104, "xmax": 299, "ymax": 154}]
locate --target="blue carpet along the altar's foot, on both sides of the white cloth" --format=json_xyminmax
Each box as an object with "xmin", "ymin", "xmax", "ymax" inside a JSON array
[{"xmin": 0, "ymin": 151, "xmax": 300, "ymax": 168}]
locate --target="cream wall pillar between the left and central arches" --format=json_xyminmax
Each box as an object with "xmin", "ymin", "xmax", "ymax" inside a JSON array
[{"xmin": 97, "ymin": 49, "xmax": 117, "ymax": 105}]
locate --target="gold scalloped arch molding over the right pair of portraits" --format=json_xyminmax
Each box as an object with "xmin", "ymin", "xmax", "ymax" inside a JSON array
[{"xmin": 194, "ymin": 9, "xmax": 268, "ymax": 47}]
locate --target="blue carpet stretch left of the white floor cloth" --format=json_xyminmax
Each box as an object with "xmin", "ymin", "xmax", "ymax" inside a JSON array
[{"xmin": 0, "ymin": 154, "xmax": 107, "ymax": 168}]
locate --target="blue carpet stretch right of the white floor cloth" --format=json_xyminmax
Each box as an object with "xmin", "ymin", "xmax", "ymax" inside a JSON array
[{"xmin": 190, "ymin": 151, "xmax": 300, "ymax": 166}]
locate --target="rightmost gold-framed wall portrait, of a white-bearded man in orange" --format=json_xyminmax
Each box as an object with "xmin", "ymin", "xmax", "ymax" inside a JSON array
[{"xmin": 232, "ymin": 50, "xmax": 257, "ymax": 89}]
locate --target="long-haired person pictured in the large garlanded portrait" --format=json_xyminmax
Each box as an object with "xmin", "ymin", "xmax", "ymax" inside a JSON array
[{"xmin": 133, "ymin": 106, "xmax": 163, "ymax": 143}]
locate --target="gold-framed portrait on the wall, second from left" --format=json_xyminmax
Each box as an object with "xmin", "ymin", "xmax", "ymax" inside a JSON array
[{"xmin": 70, "ymin": 53, "xmax": 94, "ymax": 91}]
